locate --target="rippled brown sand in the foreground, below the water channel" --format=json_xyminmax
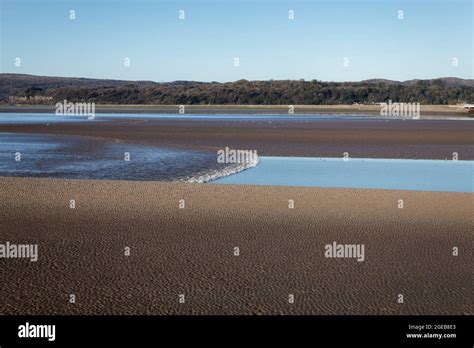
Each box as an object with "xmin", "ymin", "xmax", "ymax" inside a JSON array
[{"xmin": 0, "ymin": 178, "xmax": 474, "ymax": 315}]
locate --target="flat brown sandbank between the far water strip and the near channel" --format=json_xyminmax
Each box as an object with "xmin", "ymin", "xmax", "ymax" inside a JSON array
[{"xmin": 0, "ymin": 119, "xmax": 474, "ymax": 160}]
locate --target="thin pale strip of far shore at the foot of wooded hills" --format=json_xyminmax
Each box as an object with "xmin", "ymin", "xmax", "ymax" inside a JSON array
[{"xmin": 0, "ymin": 104, "xmax": 474, "ymax": 118}]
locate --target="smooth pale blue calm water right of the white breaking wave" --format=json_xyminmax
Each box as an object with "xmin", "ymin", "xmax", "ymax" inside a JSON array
[{"xmin": 213, "ymin": 157, "xmax": 474, "ymax": 192}]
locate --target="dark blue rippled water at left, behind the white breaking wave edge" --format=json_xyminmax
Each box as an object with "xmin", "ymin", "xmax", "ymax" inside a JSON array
[{"xmin": 0, "ymin": 133, "xmax": 234, "ymax": 181}]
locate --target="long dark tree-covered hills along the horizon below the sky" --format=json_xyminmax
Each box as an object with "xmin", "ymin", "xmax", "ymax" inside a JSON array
[{"xmin": 0, "ymin": 74, "xmax": 474, "ymax": 105}]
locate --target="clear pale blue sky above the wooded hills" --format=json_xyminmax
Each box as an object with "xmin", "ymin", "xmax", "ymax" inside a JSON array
[{"xmin": 0, "ymin": 0, "xmax": 474, "ymax": 81}]
